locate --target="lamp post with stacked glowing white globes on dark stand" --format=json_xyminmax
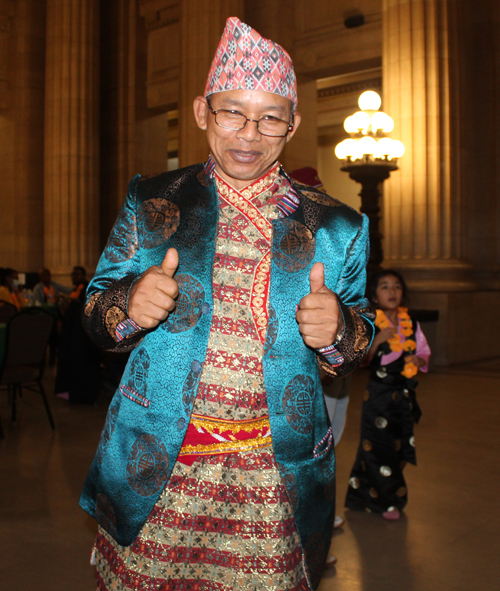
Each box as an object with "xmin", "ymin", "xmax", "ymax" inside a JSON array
[{"xmin": 335, "ymin": 90, "xmax": 405, "ymax": 272}]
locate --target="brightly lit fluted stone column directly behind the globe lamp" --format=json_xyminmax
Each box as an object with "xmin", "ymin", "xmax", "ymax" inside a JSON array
[{"xmin": 382, "ymin": 0, "xmax": 471, "ymax": 290}]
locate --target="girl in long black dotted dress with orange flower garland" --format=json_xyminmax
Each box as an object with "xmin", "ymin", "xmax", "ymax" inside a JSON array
[{"xmin": 345, "ymin": 269, "xmax": 431, "ymax": 520}]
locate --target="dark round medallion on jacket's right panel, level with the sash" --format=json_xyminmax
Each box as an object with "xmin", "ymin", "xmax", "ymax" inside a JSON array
[{"xmin": 282, "ymin": 375, "xmax": 314, "ymax": 434}]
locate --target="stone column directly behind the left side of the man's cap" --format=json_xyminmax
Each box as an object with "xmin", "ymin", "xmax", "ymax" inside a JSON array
[{"xmin": 179, "ymin": 0, "xmax": 244, "ymax": 166}]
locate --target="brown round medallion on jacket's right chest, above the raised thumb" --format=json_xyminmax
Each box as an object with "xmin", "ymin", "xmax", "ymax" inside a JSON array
[{"xmin": 273, "ymin": 218, "xmax": 316, "ymax": 273}]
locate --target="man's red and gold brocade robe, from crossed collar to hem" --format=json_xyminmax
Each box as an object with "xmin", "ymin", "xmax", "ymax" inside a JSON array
[{"xmin": 95, "ymin": 167, "xmax": 310, "ymax": 591}]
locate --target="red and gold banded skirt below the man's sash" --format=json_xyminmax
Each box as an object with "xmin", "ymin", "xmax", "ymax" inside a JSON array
[{"xmin": 94, "ymin": 446, "xmax": 311, "ymax": 591}]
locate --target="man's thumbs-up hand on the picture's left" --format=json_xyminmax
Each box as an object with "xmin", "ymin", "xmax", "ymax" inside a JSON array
[{"xmin": 128, "ymin": 248, "xmax": 179, "ymax": 328}]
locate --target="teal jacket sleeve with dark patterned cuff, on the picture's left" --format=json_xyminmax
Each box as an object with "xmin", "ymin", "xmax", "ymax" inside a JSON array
[{"xmin": 82, "ymin": 175, "xmax": 147, "ymax": 352}]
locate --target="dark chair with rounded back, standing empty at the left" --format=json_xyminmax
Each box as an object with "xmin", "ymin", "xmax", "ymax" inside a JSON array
[{"xmin": 0, "ymin": 308, "xmax": 55, "ymax": 439}]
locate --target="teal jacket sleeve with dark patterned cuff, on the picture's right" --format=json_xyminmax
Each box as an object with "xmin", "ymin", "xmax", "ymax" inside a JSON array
[{"xmin": 318, "ymin": 215, "xmax": 375, "ymax": 377}]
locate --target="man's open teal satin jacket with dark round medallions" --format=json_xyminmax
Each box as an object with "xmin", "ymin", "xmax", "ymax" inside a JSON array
[{"xmin": 80, "ymin": 164, "xmax": 373, "ymax": 588}]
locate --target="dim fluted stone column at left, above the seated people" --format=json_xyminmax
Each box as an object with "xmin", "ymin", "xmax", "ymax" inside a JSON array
[{"xmin": 44, "ymin": 0, "xmax": 99, "ymax": 276}]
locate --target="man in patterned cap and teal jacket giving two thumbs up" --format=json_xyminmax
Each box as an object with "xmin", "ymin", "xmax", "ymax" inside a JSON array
[{"xmin": 81, "ymin": 17, "xmax": 372, "ymax": 591}]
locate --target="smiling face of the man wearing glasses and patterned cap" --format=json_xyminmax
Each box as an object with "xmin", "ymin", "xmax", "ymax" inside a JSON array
[{"xmin": 194, "ymin": 90, "xmax": 300, "ymax": 189}]
